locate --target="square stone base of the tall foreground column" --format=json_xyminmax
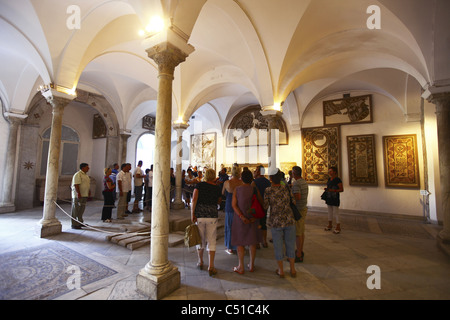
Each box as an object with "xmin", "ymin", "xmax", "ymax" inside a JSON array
[{"xmin": 136, "ymin": 267, "xmax": 181, "ymax": 300}]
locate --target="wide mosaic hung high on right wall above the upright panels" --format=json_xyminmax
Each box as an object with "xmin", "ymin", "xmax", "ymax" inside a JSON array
[{"xmin": 323, "ymin": 95, "xmax": 373, "ymax": 126}]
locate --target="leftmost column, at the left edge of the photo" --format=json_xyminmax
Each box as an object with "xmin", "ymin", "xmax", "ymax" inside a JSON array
[{"xmin": 0, "ymin": 113, "xmax": 27, "ymax": 213}]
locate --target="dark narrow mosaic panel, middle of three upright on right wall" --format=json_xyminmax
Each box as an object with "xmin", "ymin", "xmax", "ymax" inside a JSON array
[{"xmin": 347, "ymin": 134, "xmax": 378, "ymax": 186}]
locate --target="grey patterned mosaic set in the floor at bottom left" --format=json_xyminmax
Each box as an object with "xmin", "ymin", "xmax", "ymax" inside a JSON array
[{"xmin": 0, "ymin": 243, "xmax": 117, "ymax": 300}]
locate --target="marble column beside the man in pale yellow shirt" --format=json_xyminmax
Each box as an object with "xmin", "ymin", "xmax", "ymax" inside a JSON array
[{"xmin": 36, "ymin": 89, "xmax": 75, "ymax": 238}]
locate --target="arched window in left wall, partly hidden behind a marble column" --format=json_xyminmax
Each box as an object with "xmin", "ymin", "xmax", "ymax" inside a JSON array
[{"xmin": 40, "ymin": 126, "xmax": 80, "ymax": 176}]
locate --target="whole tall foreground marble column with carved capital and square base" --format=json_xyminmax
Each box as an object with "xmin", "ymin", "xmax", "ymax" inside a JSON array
[{"xmin": 136, "ymin": 29, "xmax": 193, "ymax": 300}]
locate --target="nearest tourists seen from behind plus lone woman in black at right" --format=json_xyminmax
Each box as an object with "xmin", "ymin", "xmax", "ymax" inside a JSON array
[{"xmin": 191, "ymin": 165, "xmax": 343, "ymax": 278}]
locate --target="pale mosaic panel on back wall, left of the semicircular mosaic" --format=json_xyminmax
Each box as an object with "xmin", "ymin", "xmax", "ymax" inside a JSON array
[{"xmin": 191, "ymin": 133, "xmax": 216, "ymax": 170}]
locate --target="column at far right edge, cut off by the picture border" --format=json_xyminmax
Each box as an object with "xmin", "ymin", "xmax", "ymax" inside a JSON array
[{"xmin": 428, "ymin": 92, "xmax": 450, "ymax": 254}]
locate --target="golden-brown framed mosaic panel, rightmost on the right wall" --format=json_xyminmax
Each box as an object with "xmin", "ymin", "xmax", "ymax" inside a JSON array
[{"xmin": 383, "ymin": 134, "xmax": 420, "ymax": 189}]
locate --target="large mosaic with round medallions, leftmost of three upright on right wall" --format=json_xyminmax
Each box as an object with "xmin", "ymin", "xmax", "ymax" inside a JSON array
[{"xmin": 302, "ymin": 127, "xmax": 340, "ymax": 184}]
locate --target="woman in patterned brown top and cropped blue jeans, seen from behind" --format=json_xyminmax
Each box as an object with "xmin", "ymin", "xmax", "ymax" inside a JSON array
[{"xmin": 264, "ymin": 171, "xmax": 297, "ymax": 278}]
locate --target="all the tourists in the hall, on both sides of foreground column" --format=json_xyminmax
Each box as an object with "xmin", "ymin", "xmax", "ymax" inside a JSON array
[{"xmin": 72, "ymin": 161, "xmax": 344, "ymax": 278}]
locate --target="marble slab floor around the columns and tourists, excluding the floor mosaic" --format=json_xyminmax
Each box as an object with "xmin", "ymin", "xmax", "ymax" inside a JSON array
[{"xmin": 0, "ymin": 202, "xmax": 450, "ymax": 300}]
